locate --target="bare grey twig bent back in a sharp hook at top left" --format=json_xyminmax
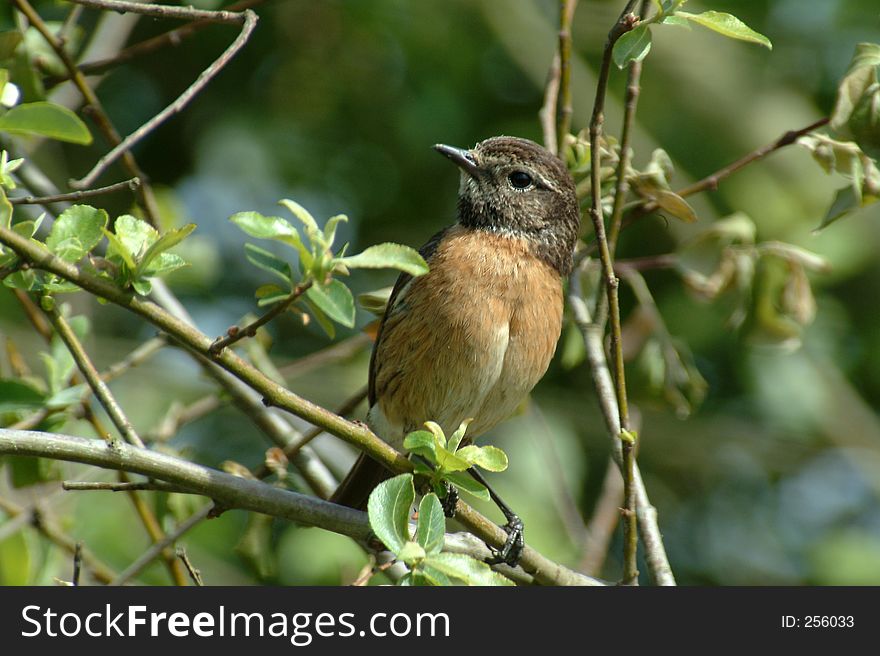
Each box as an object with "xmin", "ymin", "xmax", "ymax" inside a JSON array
[{"xmin": 72, "ymin": 9, "xmax": 257, "ymax": 189}]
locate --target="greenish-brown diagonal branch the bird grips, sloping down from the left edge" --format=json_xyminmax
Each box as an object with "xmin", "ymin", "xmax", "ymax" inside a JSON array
[{"xmin": 0, "ymin": 227, "xmax": 591, "ymax": 585}]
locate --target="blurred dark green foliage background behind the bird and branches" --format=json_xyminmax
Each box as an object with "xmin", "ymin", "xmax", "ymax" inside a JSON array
[{"xmin": 0, "ymin": 0, "xmax": 880, "ymax": 585}]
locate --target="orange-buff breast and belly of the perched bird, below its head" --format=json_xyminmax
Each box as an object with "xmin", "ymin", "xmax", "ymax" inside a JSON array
[{"xmin": 368, "ymin": 226, "xmax": 562, "ymax": 447}]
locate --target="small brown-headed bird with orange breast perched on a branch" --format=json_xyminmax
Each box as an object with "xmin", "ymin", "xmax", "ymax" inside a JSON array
[{"xmin": 331, "ymin": 136, "xmax": 580, "ymax": 563}]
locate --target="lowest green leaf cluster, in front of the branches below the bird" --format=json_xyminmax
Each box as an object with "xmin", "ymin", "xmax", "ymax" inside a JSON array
[{"xmin": 367, "ymin": 474, "xmax": 513, "ymax": 585}]
